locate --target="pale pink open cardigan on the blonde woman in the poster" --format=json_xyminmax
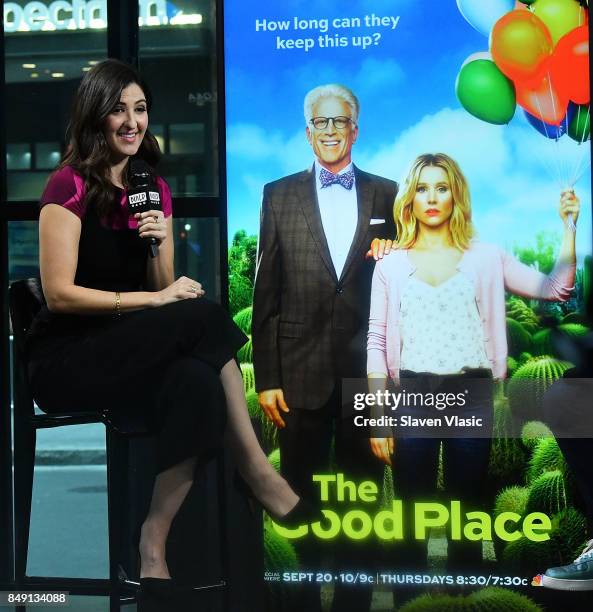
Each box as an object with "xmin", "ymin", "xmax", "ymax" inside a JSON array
[{"xmin": 367, "ymin": 242, "xmax": 576, "ymax": 379}]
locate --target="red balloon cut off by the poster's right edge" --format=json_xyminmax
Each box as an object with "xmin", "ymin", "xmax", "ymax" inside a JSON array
[{"xmin": 550, "ymin": 25, "xmax": 591, "ymax": 104}]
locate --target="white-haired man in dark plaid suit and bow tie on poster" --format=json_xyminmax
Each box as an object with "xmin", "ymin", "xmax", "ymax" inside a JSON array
[{"xmin": 252, "ymin": 84, "xmax": 397, "ymax": 612}]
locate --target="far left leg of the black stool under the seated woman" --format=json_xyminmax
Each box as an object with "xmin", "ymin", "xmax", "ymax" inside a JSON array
[{"xmin": 14, "ymin": 424, "xmax": 37, "ymax": 584}]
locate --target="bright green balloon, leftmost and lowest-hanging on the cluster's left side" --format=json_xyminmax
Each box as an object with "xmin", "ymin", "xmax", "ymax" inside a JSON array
[{"xmin": 455, "ymin": 59, "xmax": 516, "ymax": 125}]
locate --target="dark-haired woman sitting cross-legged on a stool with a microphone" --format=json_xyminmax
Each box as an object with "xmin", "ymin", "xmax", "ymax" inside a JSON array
[{"xmin": 28, "ymin": 60, "xmax": 308, "ymax": 596}]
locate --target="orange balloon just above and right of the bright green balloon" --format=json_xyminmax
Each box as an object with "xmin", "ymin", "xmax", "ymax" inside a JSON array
[{"xmin": 490, "ymin": 10, "xmax": 552, "ymax": 85}]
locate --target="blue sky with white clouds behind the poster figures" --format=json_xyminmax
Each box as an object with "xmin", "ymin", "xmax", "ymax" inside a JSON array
[{"xmin": 225, "ymin": 0, "xmax": 591, "ymax": 255}]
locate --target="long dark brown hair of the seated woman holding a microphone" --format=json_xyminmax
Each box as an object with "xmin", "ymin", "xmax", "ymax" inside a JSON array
[{"xmin": 58, "ymin": 59, "xmax": 161, "ymax": 217}]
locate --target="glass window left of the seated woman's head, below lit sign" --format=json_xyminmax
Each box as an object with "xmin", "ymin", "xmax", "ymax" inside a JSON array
[{"xmin": 3, "ymin": 0, "xmax": 107, "ymax": 200}]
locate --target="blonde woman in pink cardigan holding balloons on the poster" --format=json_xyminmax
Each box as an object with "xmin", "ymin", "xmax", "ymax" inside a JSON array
[{"xmin": 367, "ymin": 153, "xmax": 579, "ymax": 568}]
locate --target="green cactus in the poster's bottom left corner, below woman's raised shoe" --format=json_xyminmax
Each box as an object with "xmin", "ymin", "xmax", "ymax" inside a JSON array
[{"xmin": 264, "ymin": 521, "xmax": 299, "ymax": 612}]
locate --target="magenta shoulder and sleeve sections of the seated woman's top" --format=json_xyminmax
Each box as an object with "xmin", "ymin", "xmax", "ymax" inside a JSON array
[{"xmin": 39, "ymin": 166, "xmax": 173, "ymax": 230}]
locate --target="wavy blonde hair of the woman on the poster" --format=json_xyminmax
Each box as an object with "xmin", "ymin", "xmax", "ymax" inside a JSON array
[{"xmin": 393, "ymin": 153, "xmax": 475, "ymax": 251}]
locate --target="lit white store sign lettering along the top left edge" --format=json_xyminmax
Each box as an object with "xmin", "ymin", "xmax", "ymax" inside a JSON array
[{"xmin": 4, "ymin": 0, "xmax": 169, "ymax": 33}]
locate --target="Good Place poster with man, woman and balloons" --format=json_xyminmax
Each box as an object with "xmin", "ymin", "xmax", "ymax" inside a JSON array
[{"xmin": 224, "ymin": 0, "xmax": 593, "ymax": 612}]
